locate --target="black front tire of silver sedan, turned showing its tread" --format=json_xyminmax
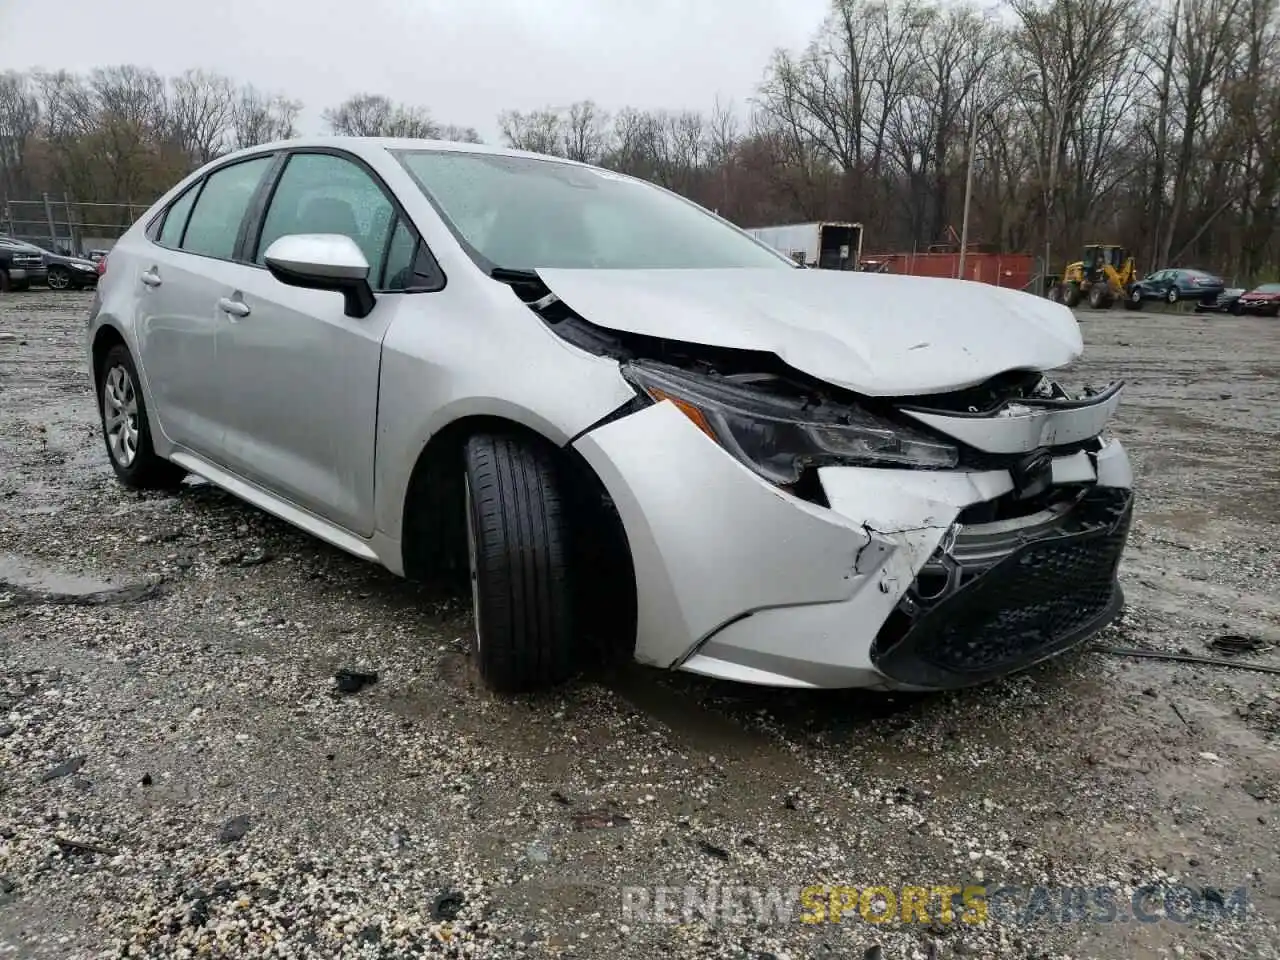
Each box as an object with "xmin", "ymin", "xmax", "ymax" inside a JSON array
[{"xmin": 463, "ymin": 434, "xmax": 575, "ymax": 694}]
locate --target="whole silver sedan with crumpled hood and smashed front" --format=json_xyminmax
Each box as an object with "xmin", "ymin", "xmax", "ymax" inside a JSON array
[{"xmin": 88, "ymin": 138, "xmax": 1133, "ymax": 691}]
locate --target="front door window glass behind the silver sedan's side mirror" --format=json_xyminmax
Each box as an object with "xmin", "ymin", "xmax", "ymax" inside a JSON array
[{"xmin": 256, "ymin": 154, "xmax": 396, "ymax": 285}]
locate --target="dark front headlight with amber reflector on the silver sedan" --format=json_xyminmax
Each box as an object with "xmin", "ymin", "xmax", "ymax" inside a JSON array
[{"xmin": 622, "ymin": 364, "xmax": 959, "ymax": 484}]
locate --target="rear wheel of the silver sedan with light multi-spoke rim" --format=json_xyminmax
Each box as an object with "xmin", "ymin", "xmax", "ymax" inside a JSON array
[{"xmin": 97, "ymin": 343, "xmax": 186, "ymax": 490}]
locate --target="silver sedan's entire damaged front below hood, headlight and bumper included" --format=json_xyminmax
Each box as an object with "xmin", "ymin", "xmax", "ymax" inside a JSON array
[{"xmin": 513, "ymin": 268, "xmax": 1133, "ymax": 689}]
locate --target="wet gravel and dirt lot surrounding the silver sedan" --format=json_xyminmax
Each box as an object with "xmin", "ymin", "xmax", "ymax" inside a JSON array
[{"xmin": 0, "ymin": 291, "xmax": 1280, "ymax": 960}]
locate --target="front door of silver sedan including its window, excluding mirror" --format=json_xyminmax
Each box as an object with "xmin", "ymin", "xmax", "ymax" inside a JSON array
[{"xmin": 218, "ymin": 151, "xmax": 412, "ymax": 536}]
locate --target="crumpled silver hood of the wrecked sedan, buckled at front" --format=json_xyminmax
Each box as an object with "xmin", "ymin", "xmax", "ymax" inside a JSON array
[{"xmin": 538, "ymin": 269, "xmax": 1083, "ymax": 397}]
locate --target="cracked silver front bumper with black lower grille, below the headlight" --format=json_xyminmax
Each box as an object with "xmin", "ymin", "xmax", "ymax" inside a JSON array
[{"xmin": 575, "ymin": 402, "xmax": 1133, "ymax": 689}]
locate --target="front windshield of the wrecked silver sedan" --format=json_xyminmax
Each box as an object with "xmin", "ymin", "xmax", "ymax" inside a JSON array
[{"xmin": 397, "ymin": 150, "xmax": 796, "ymax": 270}]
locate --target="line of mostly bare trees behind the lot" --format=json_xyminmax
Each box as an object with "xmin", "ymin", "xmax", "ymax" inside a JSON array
[{"xmin": 0, "ymin": 0, "xmax": 1280, "ymax": 283}]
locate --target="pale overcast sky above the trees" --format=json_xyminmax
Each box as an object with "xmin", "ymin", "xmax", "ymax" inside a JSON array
[{"xmin": 0, "ymin": 0, "xmax": 827, "ymax": 140}]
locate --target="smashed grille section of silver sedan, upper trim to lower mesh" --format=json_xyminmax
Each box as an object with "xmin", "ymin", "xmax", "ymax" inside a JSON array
[{"xmin": 872, "ymin": 376, "xmax": 1133, "ymax": 689}]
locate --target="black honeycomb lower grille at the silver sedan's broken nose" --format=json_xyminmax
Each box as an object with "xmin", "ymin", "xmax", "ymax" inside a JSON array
[{"xmin": 872, "ymin": 488, "xmax": 1133, "ymax": 687}]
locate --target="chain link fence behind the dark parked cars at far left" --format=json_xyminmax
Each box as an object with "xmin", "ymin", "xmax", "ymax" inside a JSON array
[{"xmin": 0, "ymin": 193, "xmax": 147, "ymax": 256}]
